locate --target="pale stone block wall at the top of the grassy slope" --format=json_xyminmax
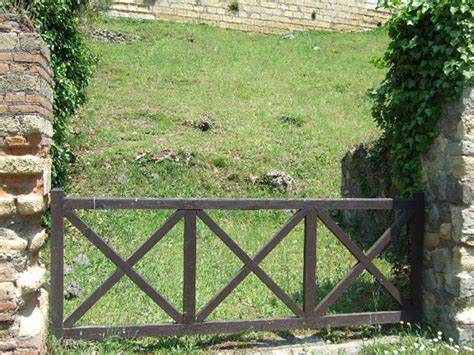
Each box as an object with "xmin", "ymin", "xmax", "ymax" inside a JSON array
[{"xmin": 109, "ymin": 0, "xmax": 390, "ymax": 33}]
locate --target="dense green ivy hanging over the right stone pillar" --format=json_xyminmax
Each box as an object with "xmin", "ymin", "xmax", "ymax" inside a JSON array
[{"xmin": 373, "ymin": 0, "xmax": 474, "ymax": 195}]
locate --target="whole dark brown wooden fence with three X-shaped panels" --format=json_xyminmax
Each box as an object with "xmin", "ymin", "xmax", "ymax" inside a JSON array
[{"xmin": 51, "ymin": 189, "xmax": 424, "ymax": 339}]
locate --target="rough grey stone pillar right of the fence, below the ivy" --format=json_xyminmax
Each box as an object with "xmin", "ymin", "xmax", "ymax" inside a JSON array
[{"xmin": 423, "ymin": 88, "xmax": 474, "ymax": 340}]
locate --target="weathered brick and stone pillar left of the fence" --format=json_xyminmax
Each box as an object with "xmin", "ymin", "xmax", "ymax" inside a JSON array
[{"xmin": 0, "ymin": 15, "xmax": 53, "ymax": 352}]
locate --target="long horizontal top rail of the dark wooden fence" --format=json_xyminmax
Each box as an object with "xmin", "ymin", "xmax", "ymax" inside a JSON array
[{"xmin": 58, "ymin": 193, "xmax": 417, "ymax": 210}]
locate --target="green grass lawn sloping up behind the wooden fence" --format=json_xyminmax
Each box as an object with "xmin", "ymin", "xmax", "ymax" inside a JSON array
[{"xmin": 49, "ymin": 18, "xmax": 394, "ymax": 351}]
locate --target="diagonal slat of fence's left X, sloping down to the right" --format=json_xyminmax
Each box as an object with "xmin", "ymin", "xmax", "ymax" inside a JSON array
[{"xmin": 64, "ymin": 211, "xmax": 182, "ymax": 323}]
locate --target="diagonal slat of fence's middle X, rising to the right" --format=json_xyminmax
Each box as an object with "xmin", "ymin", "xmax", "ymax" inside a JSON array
[{"xmin": 197, "ymin": 211, "xmax": 305, "ymax": 322}]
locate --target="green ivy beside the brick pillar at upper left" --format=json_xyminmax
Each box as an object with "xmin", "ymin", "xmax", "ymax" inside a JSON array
[{"xmin": 2, "ymin": 0, "xmax": 101, "ymax": 186}]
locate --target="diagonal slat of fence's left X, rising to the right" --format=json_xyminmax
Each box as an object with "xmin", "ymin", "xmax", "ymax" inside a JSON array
[{"xmin": 64, "ymin": 211, "xmax": 184, "ymax": 327}]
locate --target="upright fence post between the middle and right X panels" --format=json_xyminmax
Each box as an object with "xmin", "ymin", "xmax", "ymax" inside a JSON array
[{"xmin": 303, "ymin": 209, "xmax": 317, "ymax": 318}]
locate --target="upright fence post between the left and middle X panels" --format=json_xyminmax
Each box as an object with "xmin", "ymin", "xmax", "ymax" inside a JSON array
[{"xmin": 183, "ymin": 210, "xmax": 196, "ymax": 324}]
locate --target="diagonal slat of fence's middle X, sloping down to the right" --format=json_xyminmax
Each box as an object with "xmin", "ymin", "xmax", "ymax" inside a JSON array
[{"xmin": 198, "ymin": 211, "xmax": 304, "ymax": 317}]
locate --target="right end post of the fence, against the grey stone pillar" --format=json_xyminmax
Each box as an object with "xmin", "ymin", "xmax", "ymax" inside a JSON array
[{"xmin": 410, "ymin": 192, "xmax": 425, "ymax": 322}]
